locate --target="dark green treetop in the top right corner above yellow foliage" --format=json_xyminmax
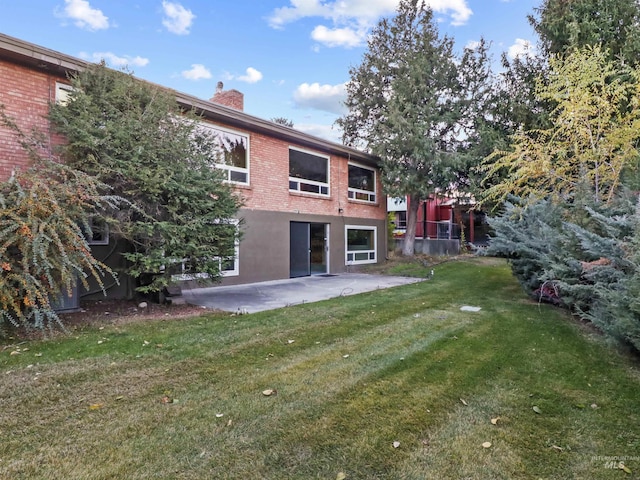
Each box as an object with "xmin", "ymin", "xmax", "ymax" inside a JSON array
[{"xmin": 529, "ymin": 0, "xmax": 640, "ymax": 66}]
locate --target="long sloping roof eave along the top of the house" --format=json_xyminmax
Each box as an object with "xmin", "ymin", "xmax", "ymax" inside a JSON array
[{"xmin": 0, "ymin": 33, "xmax": 380, "ymax": 166}]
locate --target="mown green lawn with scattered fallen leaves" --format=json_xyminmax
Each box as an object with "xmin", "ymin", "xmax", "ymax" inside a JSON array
[{"xmin": 0, "ymin": 259, "xmax": 640, "ymax": 480}]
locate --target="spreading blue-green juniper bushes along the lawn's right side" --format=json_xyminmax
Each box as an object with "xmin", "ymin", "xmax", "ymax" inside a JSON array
[{"xmin": 485, "ymin": 193, "xmax": 640, "ymax": 350}]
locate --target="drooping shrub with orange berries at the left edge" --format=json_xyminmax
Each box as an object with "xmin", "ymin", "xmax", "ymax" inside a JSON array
[{"xmin": 0, "ymin": 108, "xmax": 121, "ymax": 329}]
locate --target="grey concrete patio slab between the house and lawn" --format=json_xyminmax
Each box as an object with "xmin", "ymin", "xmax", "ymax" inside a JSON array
[{"xmin": 182, "ymin": 273, "xmax": 423, "ymax": 313}]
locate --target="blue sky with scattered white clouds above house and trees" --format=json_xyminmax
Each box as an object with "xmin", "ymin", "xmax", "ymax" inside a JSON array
[{"xmin": 0, "ymin": 0, "xmax": 542, "ymax": 141}]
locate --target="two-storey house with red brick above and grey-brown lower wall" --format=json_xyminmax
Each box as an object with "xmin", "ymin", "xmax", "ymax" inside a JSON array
[{"xmin": 0, "ymin": 34, "xmax": 387, "ymax": 297}]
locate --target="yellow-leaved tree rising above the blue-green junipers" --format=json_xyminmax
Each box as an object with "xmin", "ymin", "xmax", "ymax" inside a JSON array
[{"xmin": 485, "ymin": 46, "xmax": 640, "ymax": 207}]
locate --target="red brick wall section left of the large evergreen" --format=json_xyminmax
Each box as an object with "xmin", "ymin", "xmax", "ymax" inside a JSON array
[{"xmin": 0, "ymin": 60, "xmax": 62, "ymax": 180}]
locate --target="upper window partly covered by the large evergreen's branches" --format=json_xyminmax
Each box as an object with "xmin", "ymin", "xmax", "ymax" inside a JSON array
[{"xmin": 200, "ymin": 123, "xmax": 249, "ymax": 184}]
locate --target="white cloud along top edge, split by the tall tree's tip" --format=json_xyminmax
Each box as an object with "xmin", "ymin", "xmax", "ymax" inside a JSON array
[{"xmin": 267, "ymin": 0, "xmax": 473, "ymax": 28}]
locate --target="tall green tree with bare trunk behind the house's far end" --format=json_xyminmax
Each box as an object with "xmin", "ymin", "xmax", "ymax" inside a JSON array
[{"xmin": 337, "ymin": 0, "xmax": 490, "ymax": 255}]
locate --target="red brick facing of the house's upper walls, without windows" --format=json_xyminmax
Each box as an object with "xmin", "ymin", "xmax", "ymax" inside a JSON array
[{"xmin": 0, "ymin": 56, "xmax": 386, "ymax": 220}]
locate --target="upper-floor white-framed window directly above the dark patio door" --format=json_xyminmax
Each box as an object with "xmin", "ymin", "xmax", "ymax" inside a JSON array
[{"xmin": 289, "ymin": 148, "xmax": 329, "ymax": 195}]
